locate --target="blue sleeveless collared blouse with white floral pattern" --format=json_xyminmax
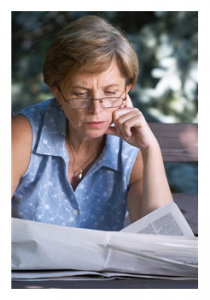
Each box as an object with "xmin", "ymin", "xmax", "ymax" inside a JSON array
[{"xmin": 12, "ymin": 98, "xmax": 139, "ymax": 231}]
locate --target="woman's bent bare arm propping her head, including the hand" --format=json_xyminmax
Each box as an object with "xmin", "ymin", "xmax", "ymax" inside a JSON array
[{"xmin": 107, "ymin": 99, "xmax": 173, "ymax": 222}]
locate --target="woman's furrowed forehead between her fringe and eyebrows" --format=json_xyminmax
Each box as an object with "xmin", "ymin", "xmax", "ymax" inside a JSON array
[{"xmin": 64, "ymin": 63, "xmax": 125, "ymax": 89}]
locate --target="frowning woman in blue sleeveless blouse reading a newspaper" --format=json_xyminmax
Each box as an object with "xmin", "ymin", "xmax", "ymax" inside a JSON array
[{"xmin": 12, "ymin": 16, "xmax": 172, "ymax": 230}]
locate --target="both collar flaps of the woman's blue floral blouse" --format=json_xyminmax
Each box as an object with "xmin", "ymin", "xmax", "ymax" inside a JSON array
[{"xmin": 36, "ymin": 98, "xmax": 122, "ymax": 172}]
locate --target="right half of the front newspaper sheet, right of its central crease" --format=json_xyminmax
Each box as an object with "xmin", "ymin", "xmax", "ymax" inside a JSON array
[{"xmin": 105, "ymin": 232, "xmax": 198, "ymax": 277}]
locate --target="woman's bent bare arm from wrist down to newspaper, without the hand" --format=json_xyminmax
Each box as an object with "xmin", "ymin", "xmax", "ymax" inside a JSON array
[{"xmin": 127, "ymin": 144, "xmax": 173, "ymax": 223}]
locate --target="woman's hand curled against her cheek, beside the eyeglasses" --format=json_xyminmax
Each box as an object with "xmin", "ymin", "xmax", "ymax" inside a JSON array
[{"xmin": 105, "ymin": 95, "xmax": 157, "ymax": 151}]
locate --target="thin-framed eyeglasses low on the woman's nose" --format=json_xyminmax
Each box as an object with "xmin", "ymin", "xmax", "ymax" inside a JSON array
[{"xmin": 58, "ymin": 86, "xmax": 126, "ymax": 109}]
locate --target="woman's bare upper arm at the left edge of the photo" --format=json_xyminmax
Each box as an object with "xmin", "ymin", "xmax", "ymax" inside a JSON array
[{"xmin": 11, "ymin": 115, "xmax": 32, "ymax": 196}]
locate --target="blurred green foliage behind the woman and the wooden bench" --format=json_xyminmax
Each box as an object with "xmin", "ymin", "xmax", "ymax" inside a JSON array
[{"xmin": 12, "ymin": 11, "xmax": 198, "ymax": 193}]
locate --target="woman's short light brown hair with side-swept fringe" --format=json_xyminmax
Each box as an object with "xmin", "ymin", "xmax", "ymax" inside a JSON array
[{"xmin": 43, "ymin": 16, "xmax": 139, "ymax": 88}]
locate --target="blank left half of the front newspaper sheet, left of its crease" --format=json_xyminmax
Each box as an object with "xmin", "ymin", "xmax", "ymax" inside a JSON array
[{"xmin": 12, "ymin": 218, "xmax": 108, "ymax": 271}]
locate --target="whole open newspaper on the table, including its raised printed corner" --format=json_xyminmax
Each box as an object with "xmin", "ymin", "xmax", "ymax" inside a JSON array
[{"xmin": 12, "ymin": 202, "xmax": 198, "ymax": 280}]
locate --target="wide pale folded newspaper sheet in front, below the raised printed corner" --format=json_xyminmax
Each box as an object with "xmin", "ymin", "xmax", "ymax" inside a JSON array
[{"xmin": 12, "ymin": 199, "xmax": 197, "ymax": 277}]
